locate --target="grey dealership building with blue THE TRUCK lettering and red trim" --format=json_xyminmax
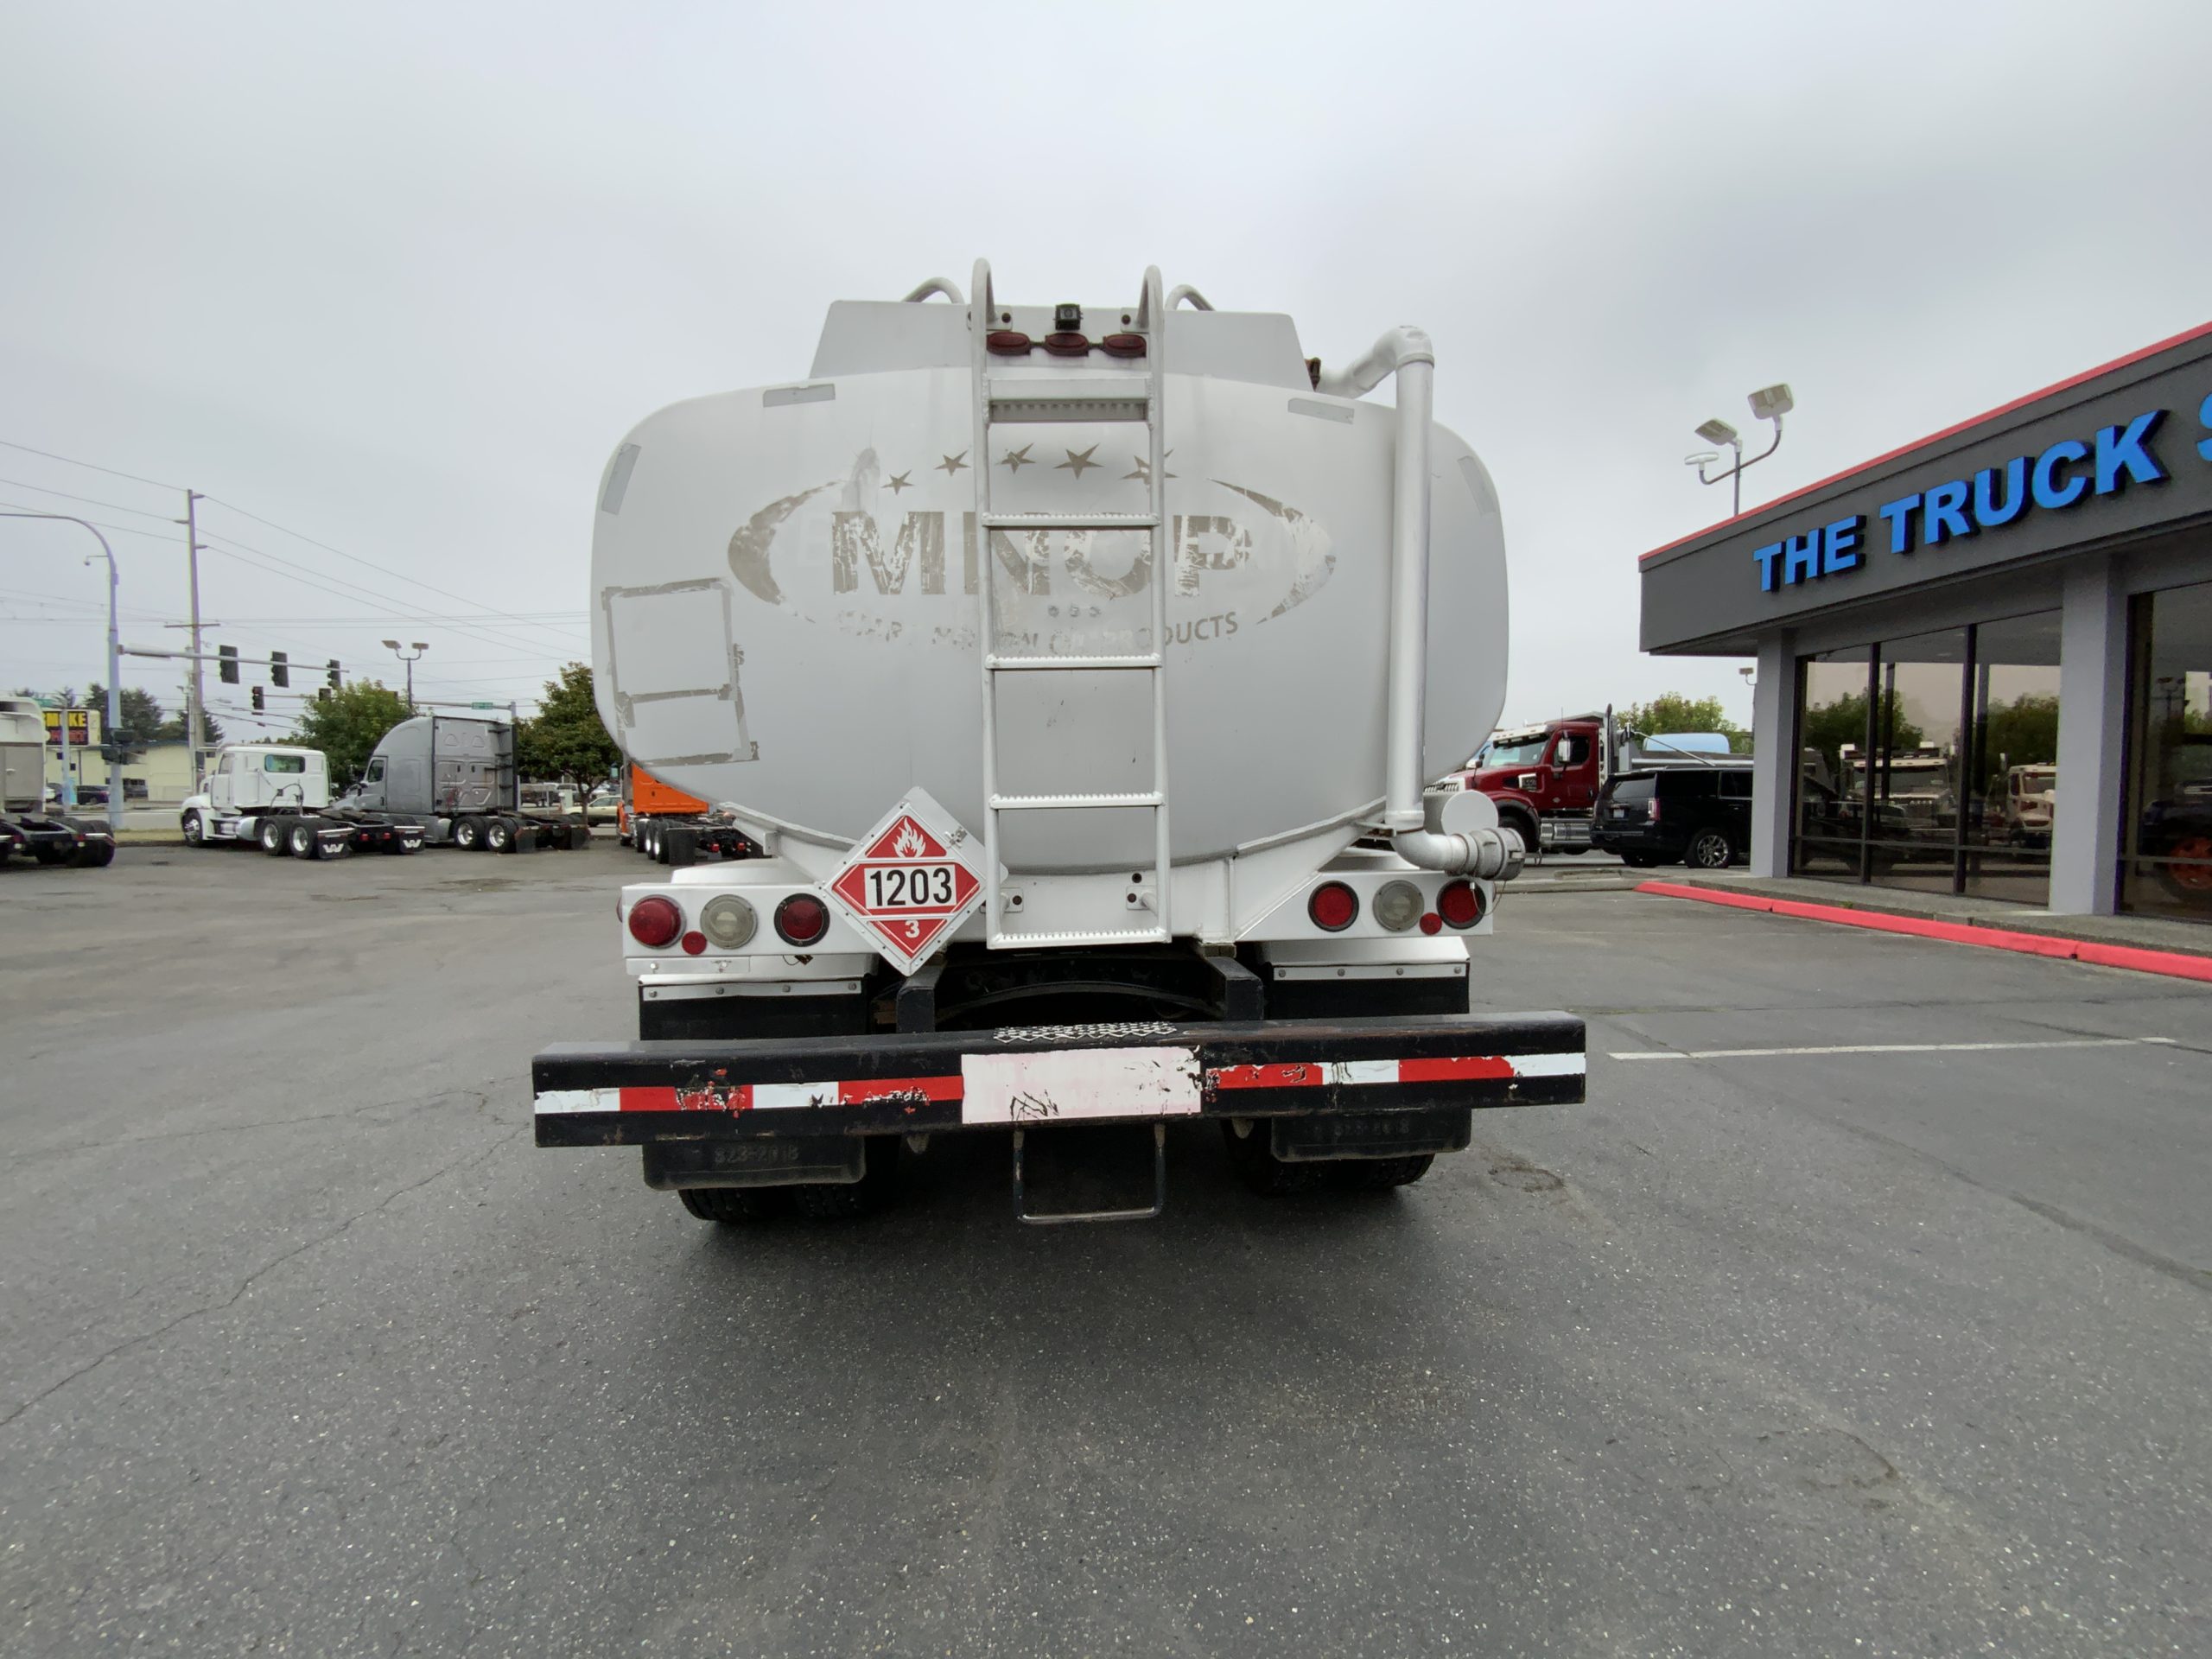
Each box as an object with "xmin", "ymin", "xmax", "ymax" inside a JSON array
[{"xmin": 1642, "ymin": 325, "xmax": 2212, "ymax": 920}]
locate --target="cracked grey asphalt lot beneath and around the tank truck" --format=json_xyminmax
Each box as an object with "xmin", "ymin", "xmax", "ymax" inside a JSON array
[{"xmin": 0, "ymin": 842, "xmax": 2212, "ymax": 1659}]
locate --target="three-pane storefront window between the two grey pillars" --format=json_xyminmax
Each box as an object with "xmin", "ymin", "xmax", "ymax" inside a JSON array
[{"xmin": 1789, "ymin": 611, "xmax": 2059, "ymax": 902}]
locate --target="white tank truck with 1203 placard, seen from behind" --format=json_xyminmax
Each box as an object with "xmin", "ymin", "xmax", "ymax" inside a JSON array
[{"xmin": 533, "ymin": 261, "xmax": 1584, "ymax": 1221}]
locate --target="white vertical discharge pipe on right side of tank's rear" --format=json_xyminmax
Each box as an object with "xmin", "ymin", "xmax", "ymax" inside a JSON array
[{"xmin": 1316, "ymin": 325, "xmax": 1522, "ymax": 878}]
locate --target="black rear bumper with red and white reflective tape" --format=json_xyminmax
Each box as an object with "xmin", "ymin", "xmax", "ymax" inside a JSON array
[{"xmin": 531, "ymin": 1013, "xmax": 1586, "ymax": 1146}]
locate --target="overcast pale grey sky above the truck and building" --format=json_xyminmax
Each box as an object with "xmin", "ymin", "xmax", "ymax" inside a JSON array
[{"xmin": 0, "ymin": 0, "xmax": 2212, "ymax": 730}]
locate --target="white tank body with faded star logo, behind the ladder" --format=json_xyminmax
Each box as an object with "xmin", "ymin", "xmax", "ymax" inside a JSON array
[{"xmin": 593, "ymin": 303, "xmax": 1506, "ymax": 869}]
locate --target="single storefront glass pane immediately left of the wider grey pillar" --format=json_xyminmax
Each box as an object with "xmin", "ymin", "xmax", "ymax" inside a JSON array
[{"xmin": 1964, "ymin": 611, "xmax": 2059, "ymax": 905}]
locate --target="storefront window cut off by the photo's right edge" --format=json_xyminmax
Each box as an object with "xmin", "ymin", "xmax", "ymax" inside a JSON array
[{"xmin": 2119, "ymin": 582, "xmax": 2212, "ymax": 920}]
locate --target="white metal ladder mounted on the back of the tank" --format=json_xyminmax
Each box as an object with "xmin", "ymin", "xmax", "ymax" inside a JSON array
[{"xmin": 969, "ymin": 259, "xmax": 1173, "ymax": 951}]
